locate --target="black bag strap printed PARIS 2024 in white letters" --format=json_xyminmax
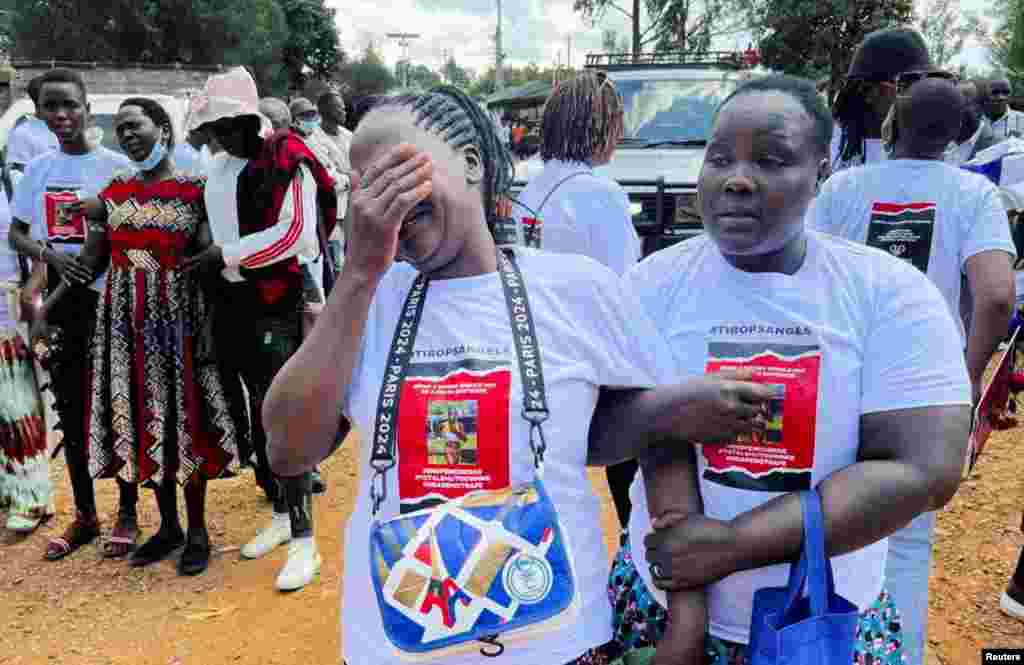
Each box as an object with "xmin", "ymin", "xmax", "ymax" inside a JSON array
[{"xmin": 370, "ymin": 249, "xmax": 550, "ymax": 516}]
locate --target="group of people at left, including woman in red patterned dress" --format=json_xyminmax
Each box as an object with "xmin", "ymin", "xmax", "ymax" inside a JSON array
[{"xmin": 0, "ymin": 64, "xmax": 350, "ymax": 589}]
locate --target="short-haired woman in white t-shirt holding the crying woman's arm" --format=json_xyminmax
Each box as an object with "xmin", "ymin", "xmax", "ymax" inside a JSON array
[{"xmin": 592, "ymin": 76, "xmax": 971, "ymax": 665}]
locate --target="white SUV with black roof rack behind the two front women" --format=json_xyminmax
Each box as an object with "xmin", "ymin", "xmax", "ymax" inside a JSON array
[{"xmin": 516, "ymin": 52, "xmax": 756, "ymax": 256}]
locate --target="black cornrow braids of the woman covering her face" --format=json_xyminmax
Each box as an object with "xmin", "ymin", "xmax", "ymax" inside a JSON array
[{"xmin": 374, "ymin": 85, "xmax": 513, "ymax": 228}]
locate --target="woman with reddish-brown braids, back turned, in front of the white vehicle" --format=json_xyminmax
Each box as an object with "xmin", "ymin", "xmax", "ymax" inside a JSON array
[{"xmin": 516, "ymin": 72, "xmax": 641, "ymax": 527}]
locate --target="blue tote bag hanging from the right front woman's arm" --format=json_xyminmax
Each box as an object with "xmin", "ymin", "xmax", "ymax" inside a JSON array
[{"xmin": 749, "ymin": 490, "xmax": 858, "ymax": 665}]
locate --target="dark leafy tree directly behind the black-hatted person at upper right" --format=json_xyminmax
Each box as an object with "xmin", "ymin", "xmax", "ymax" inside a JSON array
[{"xmin": 749, "ymin": 0, "xmax": 913, "ymax": 96}]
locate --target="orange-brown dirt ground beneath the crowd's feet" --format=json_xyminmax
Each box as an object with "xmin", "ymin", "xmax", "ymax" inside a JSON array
[{"xmin": 6, "ymin": 428, "xmax": 1024, "ymax": 665}]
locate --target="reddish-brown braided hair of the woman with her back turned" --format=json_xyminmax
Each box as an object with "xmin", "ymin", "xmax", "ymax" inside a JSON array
[{"xmin": 541, "ymin": 72, "xmax": 623, "ymax": 163}]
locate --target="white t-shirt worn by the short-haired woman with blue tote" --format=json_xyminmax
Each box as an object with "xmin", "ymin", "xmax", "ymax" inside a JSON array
[{"xmin": 626, "ymin": 232, "xmax": 971, "ymax": 643}]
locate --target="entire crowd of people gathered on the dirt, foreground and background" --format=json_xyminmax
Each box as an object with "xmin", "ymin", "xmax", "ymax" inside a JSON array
[{"xmin": 0, "ymin": 23, "xmax": 1024, "ymax": 665}]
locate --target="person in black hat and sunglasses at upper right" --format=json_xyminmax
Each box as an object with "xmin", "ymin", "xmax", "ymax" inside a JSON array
[{"xmin": 831, "ymin": 28, "xmax": 931, "ymax": 171}]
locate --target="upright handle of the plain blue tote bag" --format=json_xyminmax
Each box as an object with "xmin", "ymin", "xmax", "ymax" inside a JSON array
[{"xmin": 783, "ymin": 490, "xmax": 836, "ymax": 617}]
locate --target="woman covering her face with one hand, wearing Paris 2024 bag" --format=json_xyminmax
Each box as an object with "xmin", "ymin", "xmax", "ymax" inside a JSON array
[{"xmin": 263, "ymin": 87, "xmax": 770, "ymax": 665}]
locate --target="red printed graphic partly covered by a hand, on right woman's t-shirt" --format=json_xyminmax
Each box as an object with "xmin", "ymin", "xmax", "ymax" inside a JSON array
[{"xmin": 701, "ymin": 342, "xmax": 821, "ymax": 492}]
